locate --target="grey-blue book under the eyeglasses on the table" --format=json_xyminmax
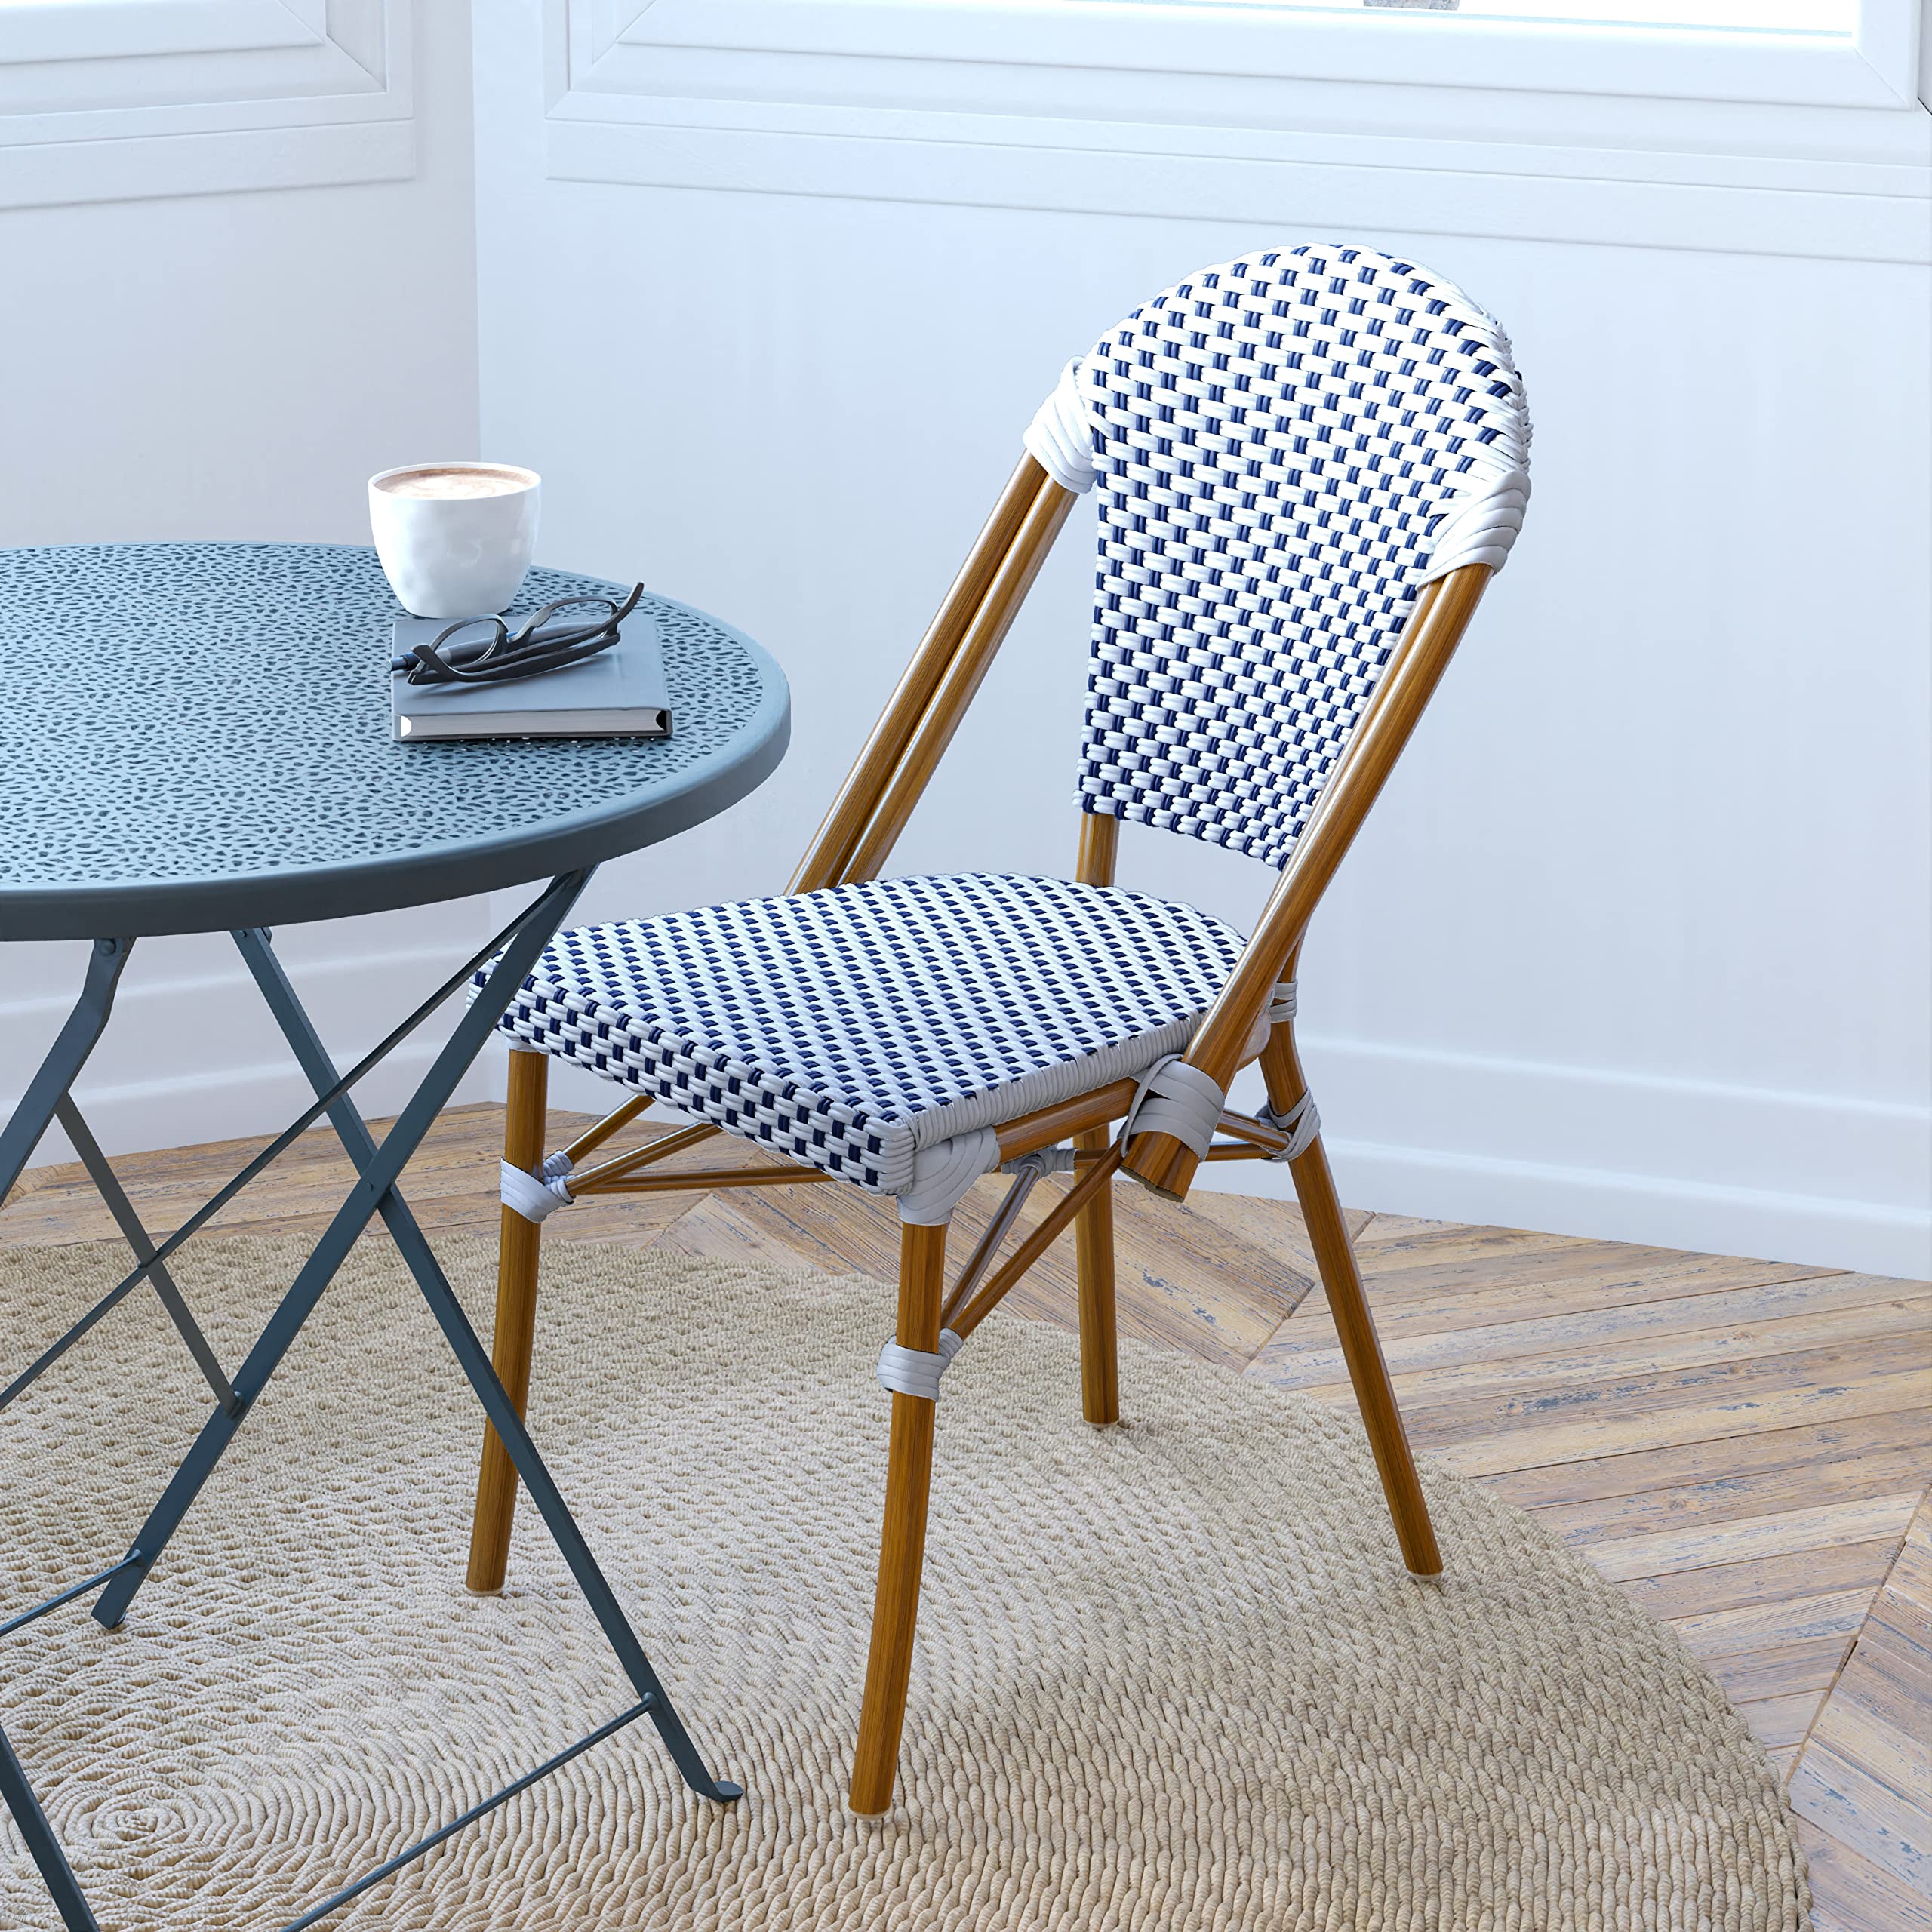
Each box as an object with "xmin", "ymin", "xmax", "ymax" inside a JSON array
[{"xmin": 389, "ymin": 611, "xmax": 670, "ymax": 744}]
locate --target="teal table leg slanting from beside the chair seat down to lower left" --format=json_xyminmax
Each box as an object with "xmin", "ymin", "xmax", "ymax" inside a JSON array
[{"xmin": 93, "ymin": 872, "xmax": 589, "ymax": 1631}]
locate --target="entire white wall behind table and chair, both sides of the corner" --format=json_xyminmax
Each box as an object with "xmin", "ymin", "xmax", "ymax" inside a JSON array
[{"xmin": 0, "ymin": 0, "xmax": 1932, "ymax": 1273}]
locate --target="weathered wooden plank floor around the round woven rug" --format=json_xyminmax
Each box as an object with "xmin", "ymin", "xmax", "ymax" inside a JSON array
[{"xmin": 0, "ymin": 1107, "xmax": 1932, "ymax": 1932}]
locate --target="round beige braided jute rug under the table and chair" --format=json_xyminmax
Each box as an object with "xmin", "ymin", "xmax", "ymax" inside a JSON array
[{"xmin": 0, "ymin": 1241, "xmax": 1807, "ymax": 1932}]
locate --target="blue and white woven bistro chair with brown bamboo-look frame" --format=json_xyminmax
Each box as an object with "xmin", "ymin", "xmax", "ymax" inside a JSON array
[{"xmin": 468, "ymin": 248, "xmax": 1531, "ymax": 1812}]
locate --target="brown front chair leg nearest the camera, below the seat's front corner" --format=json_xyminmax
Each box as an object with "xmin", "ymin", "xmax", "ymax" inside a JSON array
[{"xmin": 850, "ymin": 1223, "xmax": 946, "ymax": 1816}]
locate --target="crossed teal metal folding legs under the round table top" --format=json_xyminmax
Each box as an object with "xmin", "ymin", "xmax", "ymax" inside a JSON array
[{"xmin": 0, "ymin": 872, "xmax": 744, "ymax": 1932}]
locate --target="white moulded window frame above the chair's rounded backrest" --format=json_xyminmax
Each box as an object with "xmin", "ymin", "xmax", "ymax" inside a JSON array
[{"xmin": 543, "ymin": 0, "xmax": 1932, "ymax": 265}]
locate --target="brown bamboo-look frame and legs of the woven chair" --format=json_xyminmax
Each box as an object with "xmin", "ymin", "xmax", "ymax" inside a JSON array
[{"xmin": 468, "ymin": 456, "xmax": 1490, "ymax": 1814}]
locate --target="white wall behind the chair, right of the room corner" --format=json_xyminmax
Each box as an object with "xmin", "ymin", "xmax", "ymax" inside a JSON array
[{"xmin": 477, "ymin": 6, "xmax": 1932, "ymax": 1273}]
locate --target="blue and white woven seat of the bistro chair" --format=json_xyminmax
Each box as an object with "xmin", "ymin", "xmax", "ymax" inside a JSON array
[{"xmin": 479, "ymin": 875, "xmax": 1242, "ymax": 1194}]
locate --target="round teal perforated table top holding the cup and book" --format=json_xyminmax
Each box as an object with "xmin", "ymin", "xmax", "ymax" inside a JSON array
[{"xmin": 0, "ymin": 543, "xmax": 790, "ymax": 939}]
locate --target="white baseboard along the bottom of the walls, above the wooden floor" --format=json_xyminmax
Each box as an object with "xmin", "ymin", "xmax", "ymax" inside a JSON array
[{"xmin": 26, "ymin": 961, "xmax": 1932, "ymax": 1279}]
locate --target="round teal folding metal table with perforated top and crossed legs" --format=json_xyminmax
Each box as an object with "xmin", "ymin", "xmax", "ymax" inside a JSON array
[{"xmin": 0, "ymin": 543, "xmax": 790, "ymax": 1932}]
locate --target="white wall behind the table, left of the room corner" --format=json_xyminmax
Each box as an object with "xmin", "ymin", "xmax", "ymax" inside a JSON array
[{"xmin": 0, "ymin": 0, "xmax": 485, "ymax": 1159}]
